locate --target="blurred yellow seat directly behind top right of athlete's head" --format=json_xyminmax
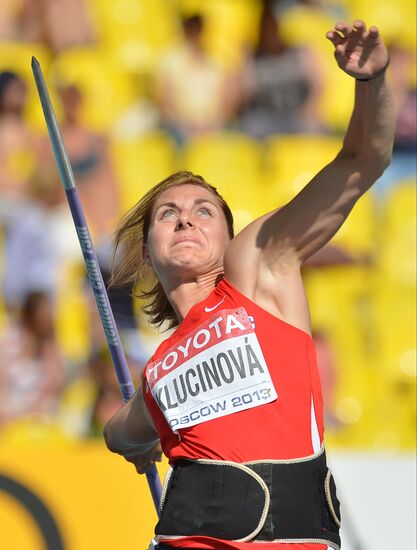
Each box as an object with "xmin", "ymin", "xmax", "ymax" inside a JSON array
[{"xmin": 183, "ymin": 132, "xmax": 271, "ymax": 225}]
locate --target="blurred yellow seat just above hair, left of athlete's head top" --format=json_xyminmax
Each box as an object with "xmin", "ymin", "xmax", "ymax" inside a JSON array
[{"xmin": 111, "ymin": 132, "xmax": 176, "ymax": 212}]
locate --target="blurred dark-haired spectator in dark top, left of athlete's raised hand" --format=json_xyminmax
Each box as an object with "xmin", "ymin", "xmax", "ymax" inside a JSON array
[{"xmin": 240, "ymin": 0, "xmax": 323, "ymax": 138}]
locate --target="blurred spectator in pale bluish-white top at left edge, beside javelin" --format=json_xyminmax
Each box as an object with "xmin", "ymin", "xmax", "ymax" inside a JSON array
[{"xmin": 0, "ymin": 169, "xmax": 67, "ymax": 311}]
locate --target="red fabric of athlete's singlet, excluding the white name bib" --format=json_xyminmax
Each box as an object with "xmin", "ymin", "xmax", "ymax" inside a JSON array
[{"xmin": 143, "ymin": 278, "xmax": 326, "ymax": 550}]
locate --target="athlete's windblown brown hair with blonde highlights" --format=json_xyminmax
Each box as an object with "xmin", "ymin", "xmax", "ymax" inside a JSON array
[{"xmin": 110, "ymin": 171, "xmax": 234, "ymax": 328}]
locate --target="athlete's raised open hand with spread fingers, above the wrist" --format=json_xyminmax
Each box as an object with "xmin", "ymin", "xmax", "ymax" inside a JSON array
[{"xmin": 326, "ymin": 19, "xmax": 389, "ymax": 79}]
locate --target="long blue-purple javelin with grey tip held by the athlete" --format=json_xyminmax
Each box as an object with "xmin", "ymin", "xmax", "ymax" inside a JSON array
[{"xmin": 32, "ymin": 57, "xmax": 161, "ymax": 515}]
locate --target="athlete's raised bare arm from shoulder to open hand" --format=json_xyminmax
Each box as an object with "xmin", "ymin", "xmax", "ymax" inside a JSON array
[{"xmin": 225, "ymin": 20, "xmax": 395, "ymax": 305}]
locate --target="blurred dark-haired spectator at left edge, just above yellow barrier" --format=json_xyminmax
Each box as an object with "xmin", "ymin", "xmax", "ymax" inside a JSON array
[{"xmin": 0, "ymin": 292, "xmax": 64, "ymax": 428}]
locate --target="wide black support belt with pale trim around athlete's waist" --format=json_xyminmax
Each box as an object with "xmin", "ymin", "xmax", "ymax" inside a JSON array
[{"xmin": 155, "ymin": 452, "xmax": 340, "ymax": 548}]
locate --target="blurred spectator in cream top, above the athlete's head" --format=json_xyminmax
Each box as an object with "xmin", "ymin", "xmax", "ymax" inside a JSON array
[{"xmin": 156, "ymin": 15, "xmax": 241, "ymax": 143}]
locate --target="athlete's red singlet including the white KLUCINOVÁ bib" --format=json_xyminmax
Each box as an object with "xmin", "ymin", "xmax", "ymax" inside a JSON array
[{"xmin": 143, "ymin": 278, "xmax": 327, "ymax": 550}]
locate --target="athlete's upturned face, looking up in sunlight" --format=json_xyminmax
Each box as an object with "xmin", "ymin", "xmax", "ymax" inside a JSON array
[{"xmin": 144, "ymin": 184, "xmax": 229, "ymax": 279}]
